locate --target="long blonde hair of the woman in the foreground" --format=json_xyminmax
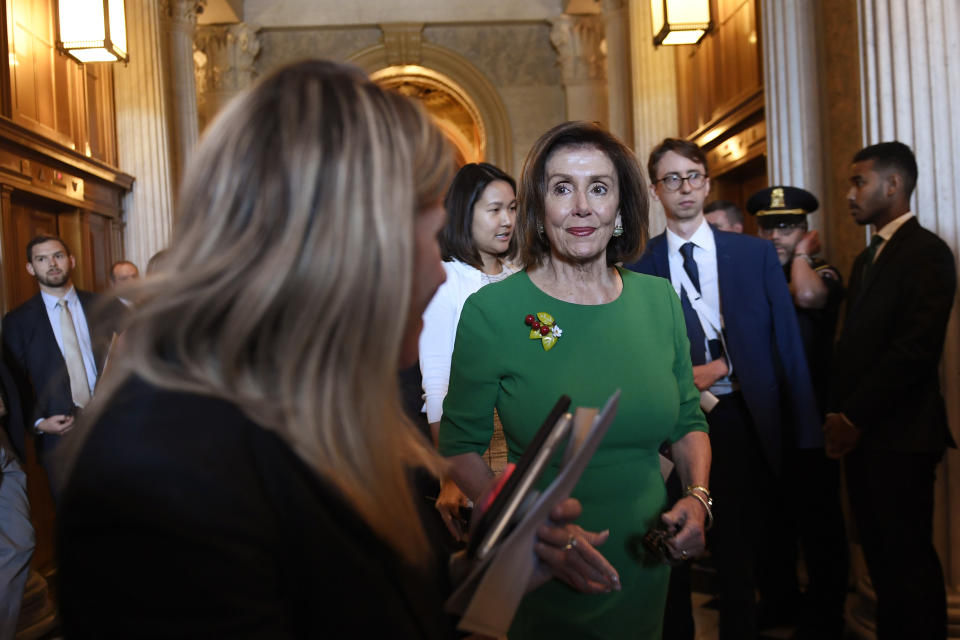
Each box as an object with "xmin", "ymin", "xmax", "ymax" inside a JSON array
[{"xmin": 72, "ymin": 61, "xmax": 453, "ymax": 563}]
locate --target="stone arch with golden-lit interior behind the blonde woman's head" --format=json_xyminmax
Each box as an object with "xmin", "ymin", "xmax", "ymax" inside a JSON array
[{"xmin": 347, "ymin": 32, "xmax": 514, "ymax": 174}]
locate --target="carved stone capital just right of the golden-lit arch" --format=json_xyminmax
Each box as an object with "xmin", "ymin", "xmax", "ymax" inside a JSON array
[{"xmin": 550, "ymin": 15, "xmax": 606, "ymax": 85}]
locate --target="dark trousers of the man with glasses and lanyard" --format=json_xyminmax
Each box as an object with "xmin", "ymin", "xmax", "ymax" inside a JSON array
[{"xmin": 707, "ymin": 392, "xmax": 768, "ymax": 640}]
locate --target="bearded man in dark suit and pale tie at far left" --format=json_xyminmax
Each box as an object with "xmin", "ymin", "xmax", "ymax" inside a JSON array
[{"xmin": 3, "ymin": 235, "xmax": 119, "ymax": 497}]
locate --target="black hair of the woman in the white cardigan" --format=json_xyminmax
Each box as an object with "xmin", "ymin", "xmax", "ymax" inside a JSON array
[{"xmin": 438, "ymin": 162, "xmax": 517, "ymax": 269}]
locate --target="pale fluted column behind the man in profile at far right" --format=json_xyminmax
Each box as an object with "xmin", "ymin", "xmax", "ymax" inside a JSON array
[{"xmin": 858, "ymin": 0, "xmax": 960, "ymax": 638}]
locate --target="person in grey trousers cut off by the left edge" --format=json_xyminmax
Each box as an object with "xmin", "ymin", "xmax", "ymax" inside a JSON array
[{"xmin": 0, "ymin": 361, "xmax": 34, "ymax": 640}]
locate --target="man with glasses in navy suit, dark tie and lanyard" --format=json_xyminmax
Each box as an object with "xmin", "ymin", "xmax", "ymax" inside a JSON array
[{"xmin": 629, "ymin": 138, "xmax": 823, "ymax": 640}]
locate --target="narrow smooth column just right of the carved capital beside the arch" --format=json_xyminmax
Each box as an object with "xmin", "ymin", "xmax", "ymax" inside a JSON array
[{"xmin": 601, "ymin": 0, "xmax": 633, "ymax": 145}]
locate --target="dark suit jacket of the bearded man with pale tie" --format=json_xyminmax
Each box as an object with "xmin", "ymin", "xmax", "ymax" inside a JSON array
[{"xmin": 3, "ymin": 289, "xmax": 120, "ymax": 444}]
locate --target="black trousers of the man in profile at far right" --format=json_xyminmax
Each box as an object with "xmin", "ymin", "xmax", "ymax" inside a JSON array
[{"xmin": 844, "ymin": 447, "xmax": 947, "ymax": 640}]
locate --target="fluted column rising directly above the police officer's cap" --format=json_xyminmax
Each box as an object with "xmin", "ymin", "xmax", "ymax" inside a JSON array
[{"xmin": 761, "ymin": 0, "xmax": 824, "ymax": 235}]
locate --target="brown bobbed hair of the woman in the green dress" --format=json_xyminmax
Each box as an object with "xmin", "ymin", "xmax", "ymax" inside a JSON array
[{"xmin": 517, "ymin": 121, "xmax": 649, "ymax": 267}]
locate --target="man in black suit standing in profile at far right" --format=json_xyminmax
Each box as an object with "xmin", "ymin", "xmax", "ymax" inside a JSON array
[{"xmin": 824, "ymin": 142, "xmax": 957, "ymax": 640}]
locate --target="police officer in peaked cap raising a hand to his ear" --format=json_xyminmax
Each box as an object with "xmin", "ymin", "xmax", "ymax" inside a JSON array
[{"xmin": 747, "ymin": 186, "xmax": 848, "ymax": 639}]
